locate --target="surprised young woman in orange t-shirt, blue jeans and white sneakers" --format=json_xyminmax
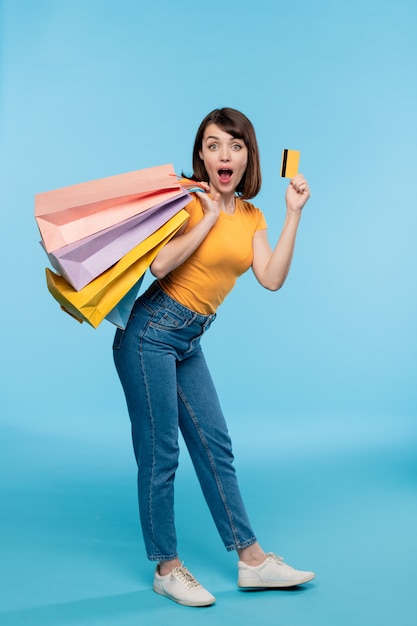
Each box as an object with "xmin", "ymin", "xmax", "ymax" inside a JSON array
[{"xmin": 113, "ymin": 108, "xmax": 314, "ymax": 606}]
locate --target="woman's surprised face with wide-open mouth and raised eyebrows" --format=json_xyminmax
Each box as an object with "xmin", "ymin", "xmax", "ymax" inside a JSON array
[{"xmin": 199, "ymin": 124, "xmax": 248, "ymax": 194}]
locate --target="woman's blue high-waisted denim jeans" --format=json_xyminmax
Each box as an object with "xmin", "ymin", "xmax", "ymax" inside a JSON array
[{"xmin": 113, "ymin": 282, "xmax": 256, "ymax": 561}]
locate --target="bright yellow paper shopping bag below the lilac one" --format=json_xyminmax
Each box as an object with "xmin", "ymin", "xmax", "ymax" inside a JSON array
[{"xmin": 45, "ymin": 209, "xmax": 189, "ymax": 328}]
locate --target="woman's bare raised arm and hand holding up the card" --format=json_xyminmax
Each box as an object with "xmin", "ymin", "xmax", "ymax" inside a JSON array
[{"xmin": 252, "ymin": 174, "xmax": 310, "ymax": 291}]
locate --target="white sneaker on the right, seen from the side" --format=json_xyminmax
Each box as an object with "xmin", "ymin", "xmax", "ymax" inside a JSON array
[{"xmin": 237, "ymin": 552, "xmax": 315, "ymax": 588}]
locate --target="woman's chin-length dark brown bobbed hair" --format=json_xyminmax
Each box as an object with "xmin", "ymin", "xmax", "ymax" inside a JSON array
[{"xmin": 191, "ymin": 107, "xmax": 262, "ymax": 199}]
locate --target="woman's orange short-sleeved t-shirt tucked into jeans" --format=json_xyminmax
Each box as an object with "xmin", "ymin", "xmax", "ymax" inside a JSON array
[{"xmin": 159, "ymin": 197, "xmax": 267, "ymax": 315}]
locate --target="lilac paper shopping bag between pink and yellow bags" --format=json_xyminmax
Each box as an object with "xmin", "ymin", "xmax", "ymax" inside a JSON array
[{"xmin": 44, "ymin": 189, "xmax": 191, "ymax": 291}]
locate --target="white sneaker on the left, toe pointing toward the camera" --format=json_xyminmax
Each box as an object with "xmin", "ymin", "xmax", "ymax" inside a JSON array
[{"xmin": 153, "ymin": 565, "xmax": 216, "ymax": 606}]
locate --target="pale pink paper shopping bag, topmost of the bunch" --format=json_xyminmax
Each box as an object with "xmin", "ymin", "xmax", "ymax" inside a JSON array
[{"xmin": 35, "ymin": 165, "xmax": 181, "ymax": 252}]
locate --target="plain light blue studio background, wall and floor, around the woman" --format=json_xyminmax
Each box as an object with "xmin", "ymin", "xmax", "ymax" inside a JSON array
[{"xmin": 0, "ymin": 0, "xmax": 417, "ymax": 626}]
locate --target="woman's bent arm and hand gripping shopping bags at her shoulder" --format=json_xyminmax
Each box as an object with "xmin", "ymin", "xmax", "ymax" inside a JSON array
[{"xmin": 150, "ymin": 185, "xmax": 220, "ymax": 278}]
